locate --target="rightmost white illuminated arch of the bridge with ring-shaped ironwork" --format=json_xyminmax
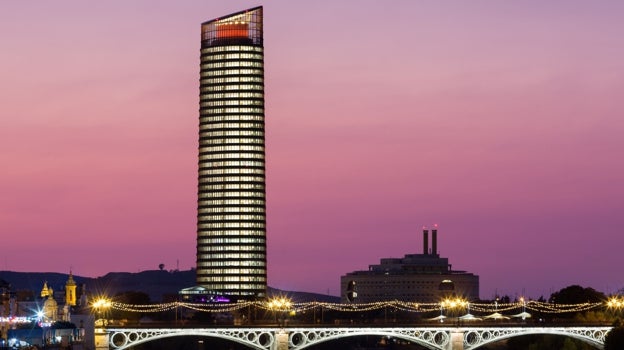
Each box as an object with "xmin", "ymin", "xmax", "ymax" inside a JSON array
[{"xmin": 463, "ymin": 327, "xmax": 611, "ymax": 350}]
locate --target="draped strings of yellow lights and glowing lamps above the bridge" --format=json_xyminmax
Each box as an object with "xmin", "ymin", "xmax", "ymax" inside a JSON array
[{"xmin": 103, "ymin": 299, "xmax": 624, "ymax": 314}]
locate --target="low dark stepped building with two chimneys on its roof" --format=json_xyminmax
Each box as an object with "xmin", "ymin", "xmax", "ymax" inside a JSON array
[{"xmin": 340, "ymin": 229, "xmax": 479, "ymax": 303}]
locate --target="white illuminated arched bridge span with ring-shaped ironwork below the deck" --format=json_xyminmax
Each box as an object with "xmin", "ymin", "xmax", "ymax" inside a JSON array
[{"xmin": 95, "ymin": 326, "xmax": 611, "ymax": 350}]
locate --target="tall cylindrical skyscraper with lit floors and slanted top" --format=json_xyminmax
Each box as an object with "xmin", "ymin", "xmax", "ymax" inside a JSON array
[{"xmin": 197, "ymin": 7, "xmax": 267, "ymax": 298}]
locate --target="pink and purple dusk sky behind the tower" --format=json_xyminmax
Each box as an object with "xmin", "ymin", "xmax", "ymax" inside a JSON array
[{"xmin": 0, "ymin": 0, "xmax": 624, "ymax": 298}]
